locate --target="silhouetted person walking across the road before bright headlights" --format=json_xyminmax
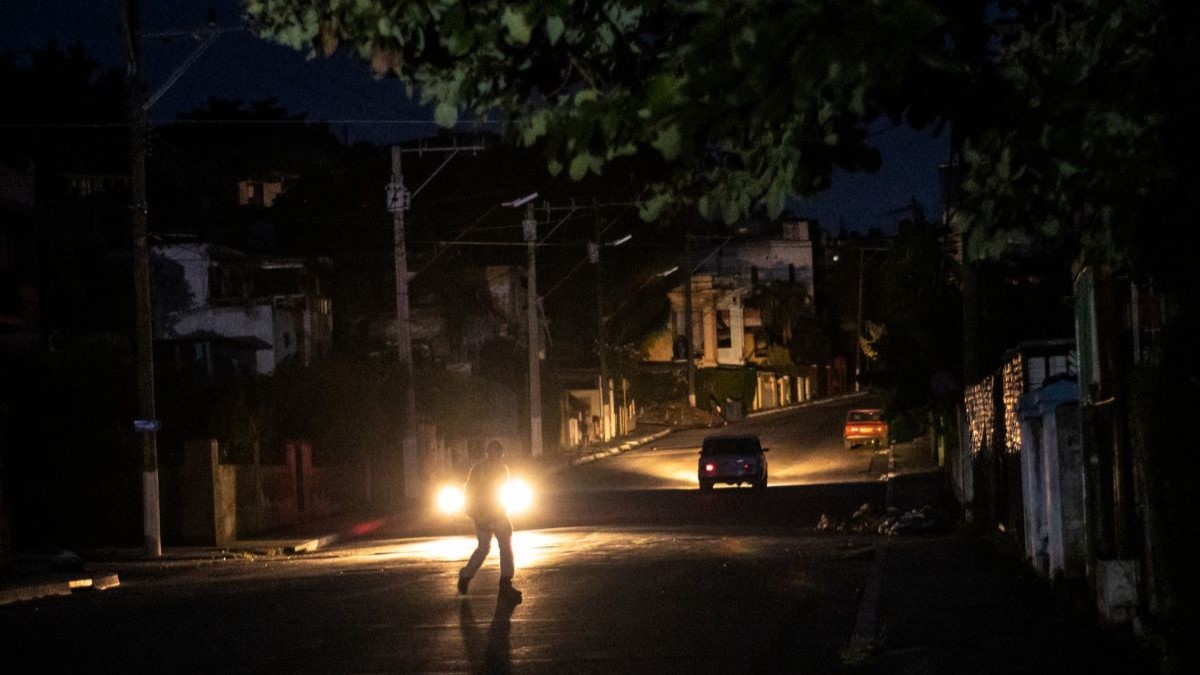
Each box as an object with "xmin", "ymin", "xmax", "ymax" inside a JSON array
[{"xmin": 458, "ymin": 441, "xmax": 521, "ymax": 604}]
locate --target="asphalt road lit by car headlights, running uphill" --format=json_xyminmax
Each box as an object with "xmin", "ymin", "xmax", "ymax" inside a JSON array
[{"xmin": 0, "ymin": 391, "xmax": 907, "ymax": 675}]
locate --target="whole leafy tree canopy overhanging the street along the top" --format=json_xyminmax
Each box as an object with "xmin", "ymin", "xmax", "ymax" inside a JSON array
[{"xmin": 246, "ymin": 0, "xmax": 1198, "ymax": 277}]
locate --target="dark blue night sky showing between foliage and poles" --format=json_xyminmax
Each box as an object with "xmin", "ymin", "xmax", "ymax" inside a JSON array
[{"xmin": 0, "ymin": 0, "xmax": 947, "ymax": 231}]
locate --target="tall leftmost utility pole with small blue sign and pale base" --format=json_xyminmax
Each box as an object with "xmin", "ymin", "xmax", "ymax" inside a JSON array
[{"xmin": 125, "ymin": 0, "xmax": 162, "ymax": 557}]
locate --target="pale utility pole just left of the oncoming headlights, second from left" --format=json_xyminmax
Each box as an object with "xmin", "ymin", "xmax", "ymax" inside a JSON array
[{"xmin": 388, "ymin": 145, "xmax": 421, "ymax": 500}]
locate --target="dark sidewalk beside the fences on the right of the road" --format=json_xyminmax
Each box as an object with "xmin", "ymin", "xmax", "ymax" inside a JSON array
[{"xmin": 844, "ymin": 466, "xmax": 1158, "ymax": 675}]
